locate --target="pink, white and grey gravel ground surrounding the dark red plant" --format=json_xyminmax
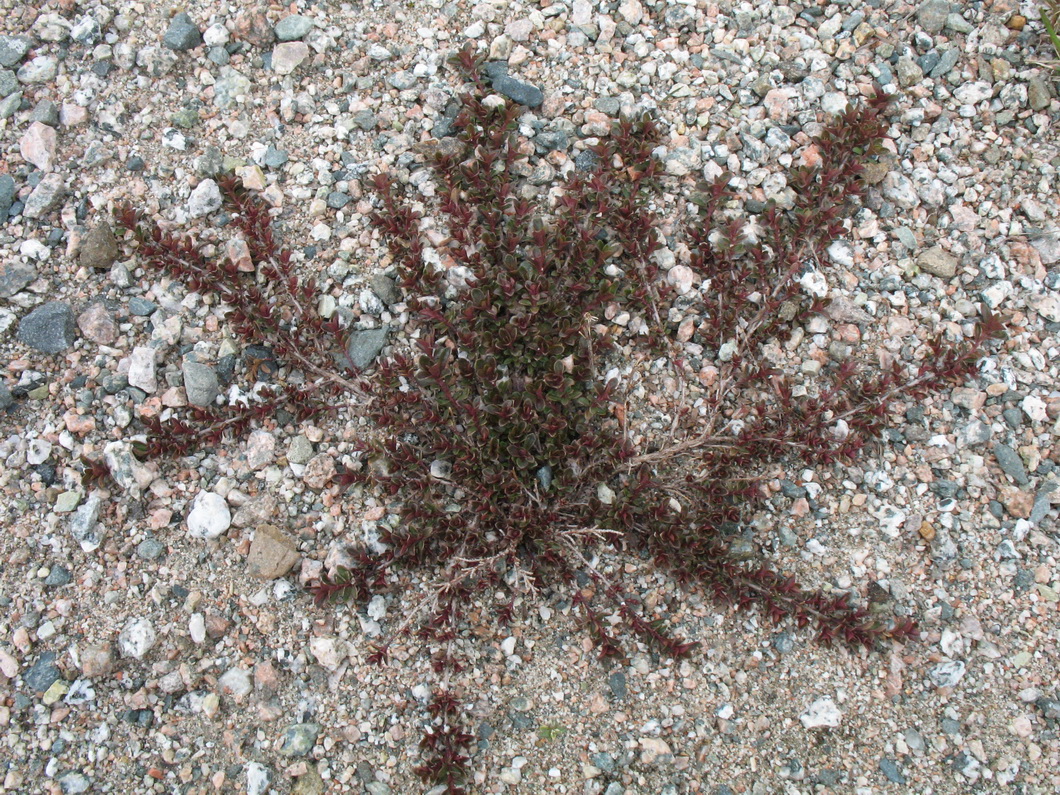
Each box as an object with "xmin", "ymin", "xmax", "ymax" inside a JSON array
[{"xmin": 0, "ymin": 0, "xmax": 1060, "ymax": 795}]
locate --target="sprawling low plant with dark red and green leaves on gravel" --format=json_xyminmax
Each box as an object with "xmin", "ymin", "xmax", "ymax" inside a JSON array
[{"xmin": 117, "ymin": 51, "xmax": 1000, "ymax": 792}]
